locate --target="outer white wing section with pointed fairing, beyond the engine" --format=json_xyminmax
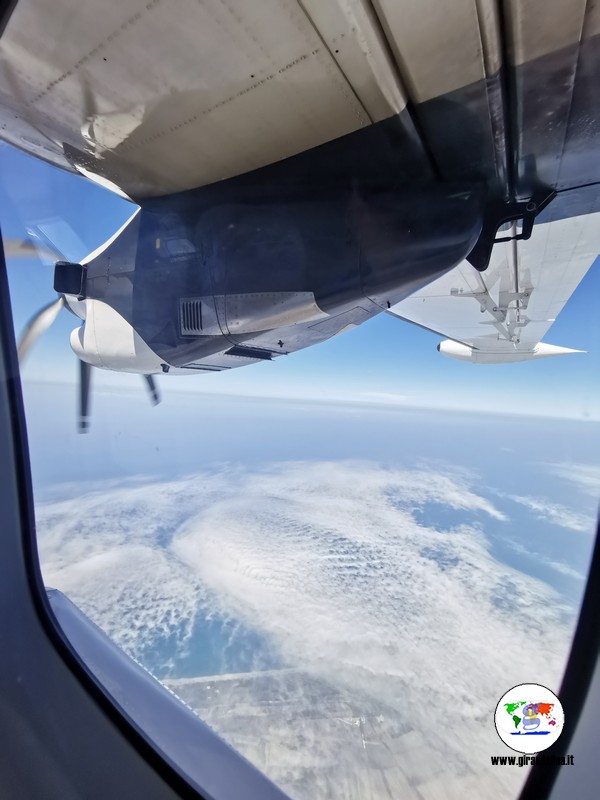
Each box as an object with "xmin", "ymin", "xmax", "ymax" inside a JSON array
[{"xmin": 388, "ymin": 212, "xmax": 600, "ymax": 363}]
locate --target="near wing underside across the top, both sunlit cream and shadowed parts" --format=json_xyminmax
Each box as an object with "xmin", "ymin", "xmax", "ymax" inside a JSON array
[{"xmin": 0, "ymin": 0, "xmax": 600, "ymax": 202}]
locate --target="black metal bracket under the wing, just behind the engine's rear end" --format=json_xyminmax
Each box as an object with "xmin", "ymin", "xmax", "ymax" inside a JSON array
[{"xmin": 467, "ymin": 187, "xmax": 556, "ymax": 272}]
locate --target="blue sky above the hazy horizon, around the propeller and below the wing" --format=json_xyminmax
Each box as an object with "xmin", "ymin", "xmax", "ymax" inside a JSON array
[{"xmin": 0, "ymin": 145, "xmax": 600, "ymax": 420}]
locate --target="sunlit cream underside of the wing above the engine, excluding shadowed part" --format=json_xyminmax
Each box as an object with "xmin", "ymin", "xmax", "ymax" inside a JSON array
[{"xmin": 0, "ymin": 0, "xmax": 600, "ymax": 199}]
